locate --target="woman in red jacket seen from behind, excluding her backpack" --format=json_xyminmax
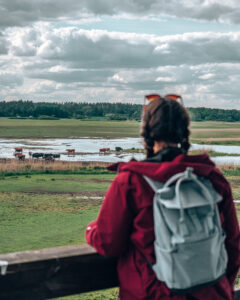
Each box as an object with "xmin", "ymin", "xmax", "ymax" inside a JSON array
[{"xmin": 86, "ymin": 95, "xmax": 240, "ymax": 300}]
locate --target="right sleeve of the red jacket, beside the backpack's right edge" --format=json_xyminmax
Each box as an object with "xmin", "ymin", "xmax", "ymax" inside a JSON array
[{"xmin": 221, "ymin": 186, "xmax": 240, "ymax": 289}]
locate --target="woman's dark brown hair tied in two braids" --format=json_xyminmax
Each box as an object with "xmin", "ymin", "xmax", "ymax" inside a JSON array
[{"xmin": 140, "ymin": 97, "xmax": 190, "ymax": 158}]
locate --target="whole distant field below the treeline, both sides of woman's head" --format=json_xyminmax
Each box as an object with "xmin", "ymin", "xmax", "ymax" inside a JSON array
[{"xmin": 0, "ymin": 118, "xmax": 240, "ymax": 144}]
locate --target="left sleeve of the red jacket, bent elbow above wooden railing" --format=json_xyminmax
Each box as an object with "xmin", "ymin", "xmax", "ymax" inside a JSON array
[{"xmin": 86, "ymin": 173, "xmax": 133, "ymax": 256}]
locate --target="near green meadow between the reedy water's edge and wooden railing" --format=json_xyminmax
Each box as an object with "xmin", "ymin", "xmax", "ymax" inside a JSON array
[{"xmin": 0, "ymin": 169, "xmax": 240, "ymax": 300}]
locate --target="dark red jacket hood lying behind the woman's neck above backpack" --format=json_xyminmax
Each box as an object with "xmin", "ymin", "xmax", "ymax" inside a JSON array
[{"xmin": 108, "ymin": 154, "xmax": 220, "ymax": 182}]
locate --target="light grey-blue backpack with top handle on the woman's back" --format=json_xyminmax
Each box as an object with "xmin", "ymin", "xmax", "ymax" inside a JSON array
[{"xmin": 144, "ymin": 168, "xmax": 227, "ymax": 293}]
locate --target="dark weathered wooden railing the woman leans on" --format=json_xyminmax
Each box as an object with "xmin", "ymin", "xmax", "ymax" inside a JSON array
[{"xmin": 0, "ymin": 245, "xmax": 240, "ymax": 300}]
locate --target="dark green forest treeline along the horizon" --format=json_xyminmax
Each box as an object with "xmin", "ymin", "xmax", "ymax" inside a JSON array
[{"xmin": 0, "ymin": 100, "xmax": 240, "ymax": 122}]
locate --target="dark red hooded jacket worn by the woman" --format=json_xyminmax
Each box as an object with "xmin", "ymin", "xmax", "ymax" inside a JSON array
[{"xmin": 86, "ymin": 154, "xmax": 240, "ymax": 300}]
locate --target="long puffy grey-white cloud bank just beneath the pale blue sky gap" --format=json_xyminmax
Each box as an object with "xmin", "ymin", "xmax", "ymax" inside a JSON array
[{"xmin": 9, "ymin": 27, "xmax": 240, "ymax": 69}]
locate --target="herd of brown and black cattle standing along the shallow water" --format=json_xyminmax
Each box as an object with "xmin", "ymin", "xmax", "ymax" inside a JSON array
[{"xmin": 14, "ymin": 147, "xmax": 123, "ymax": 161}]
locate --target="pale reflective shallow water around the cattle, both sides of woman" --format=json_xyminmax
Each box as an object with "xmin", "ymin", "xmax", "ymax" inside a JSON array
[{"xmin": 0, "ymin": 138, "xmax": 240, "ymax": 165}]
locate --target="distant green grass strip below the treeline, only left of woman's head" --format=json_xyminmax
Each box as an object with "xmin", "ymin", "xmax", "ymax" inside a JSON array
[{"xmin": 0, "ymin": 118, "xmax": 139, "ymax": 138}]
